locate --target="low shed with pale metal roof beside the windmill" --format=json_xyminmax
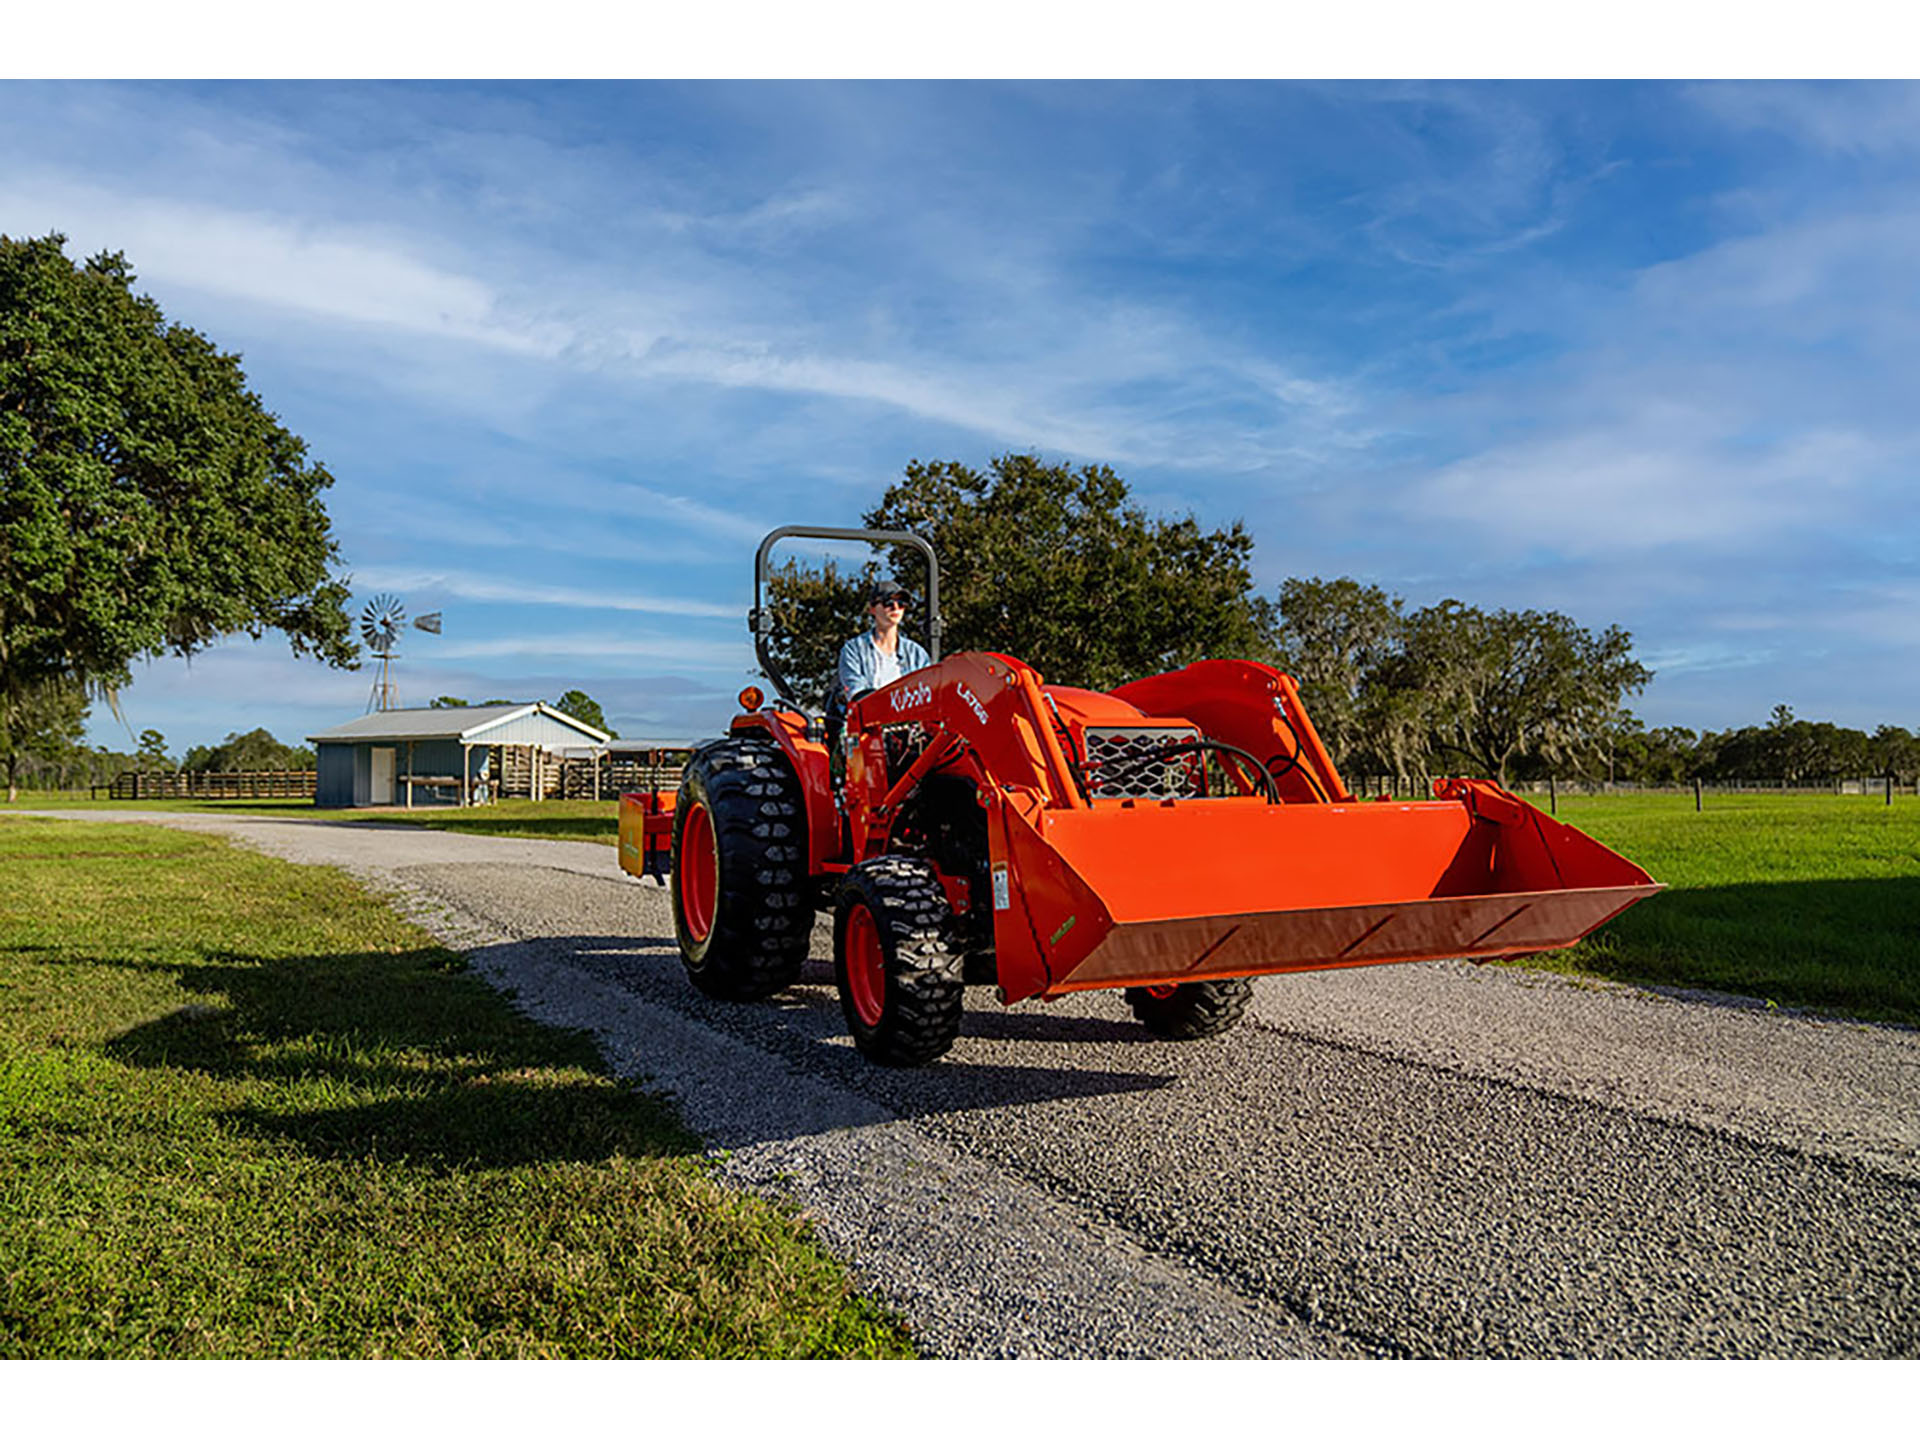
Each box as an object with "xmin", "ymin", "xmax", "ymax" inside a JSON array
[{"xmin": 307, "ymin": 701, "xmax": 607, "ymax": 808}]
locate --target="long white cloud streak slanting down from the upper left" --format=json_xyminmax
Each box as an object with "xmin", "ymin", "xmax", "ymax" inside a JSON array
[{"xmin": 0, "ymin": 100, "xmax": 1371, "ymax": 480}]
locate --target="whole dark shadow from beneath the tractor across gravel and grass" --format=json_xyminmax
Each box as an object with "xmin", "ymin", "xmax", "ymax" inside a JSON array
[{"xmin": 93, "ymin": 917, "xmax": 1179, "ymax": 1167}]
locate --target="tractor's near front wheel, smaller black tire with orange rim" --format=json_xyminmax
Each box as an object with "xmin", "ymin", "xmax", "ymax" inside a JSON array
[{"xmin": 833, "ymin": 854, "xmax": 966, "ymax": 1066}]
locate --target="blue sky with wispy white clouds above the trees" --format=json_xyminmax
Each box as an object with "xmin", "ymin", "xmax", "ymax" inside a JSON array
[{"xmin": 0, "ymin": 83, "xmax": 1920, "ymax": 753}]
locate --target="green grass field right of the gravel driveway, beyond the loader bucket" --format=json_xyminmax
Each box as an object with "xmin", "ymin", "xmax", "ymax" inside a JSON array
[{"xmin": 1528, "ymin": 795, "xmax": 1920, "ymax": 1023}]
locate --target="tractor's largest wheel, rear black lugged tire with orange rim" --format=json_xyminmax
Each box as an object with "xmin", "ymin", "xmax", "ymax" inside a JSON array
[{"xmin": 672, "ymin": 735, "xmax": 812, "ymax": 1000}]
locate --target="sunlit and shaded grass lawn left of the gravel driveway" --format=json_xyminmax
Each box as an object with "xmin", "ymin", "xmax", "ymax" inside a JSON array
[{"xmin": 0, "ymin": 816, "xmax": 910, "ymax": 1357}]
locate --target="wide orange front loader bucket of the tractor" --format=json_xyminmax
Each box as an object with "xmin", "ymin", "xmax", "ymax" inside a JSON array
[{"xmin": 996, "ymin": 781, "xmax": 1661, "ymax": 1000}]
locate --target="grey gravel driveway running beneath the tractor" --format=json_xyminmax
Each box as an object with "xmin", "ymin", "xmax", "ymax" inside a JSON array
[{"xmin": 41, "ymin": 814, "xmax": 1920, "ymax": 1356}]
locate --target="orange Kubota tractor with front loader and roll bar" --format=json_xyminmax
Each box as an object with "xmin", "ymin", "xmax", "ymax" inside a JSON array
[{"xmin": 620, "ymin": 526, "xmax": 1661, "ymax": 1066}]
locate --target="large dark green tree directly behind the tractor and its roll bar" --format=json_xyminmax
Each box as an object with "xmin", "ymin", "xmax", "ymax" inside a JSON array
[{"xmin": 768, "ymin": 455, "xmax": 1265, "ymax": 705}]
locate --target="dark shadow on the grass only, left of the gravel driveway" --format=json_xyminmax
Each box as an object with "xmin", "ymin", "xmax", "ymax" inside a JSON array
[{"xmin": 106, "ymin": 948, "xmax": 699, "ymax": 1169}]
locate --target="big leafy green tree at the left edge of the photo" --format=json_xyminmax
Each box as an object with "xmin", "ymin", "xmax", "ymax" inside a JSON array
[{"xmin": 0, "ymin": 234, "xmax": 357, "ymax": 748}]
